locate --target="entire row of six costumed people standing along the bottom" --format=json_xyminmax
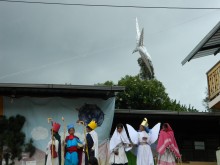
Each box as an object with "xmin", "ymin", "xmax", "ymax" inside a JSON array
[{"xmin": 45, "ymin": 118, "xmax": 181, "ymax": 165}]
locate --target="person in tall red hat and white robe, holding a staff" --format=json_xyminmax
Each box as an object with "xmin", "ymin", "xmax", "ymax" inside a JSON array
[{"xmin": 46, "ymin": 122, "xmax": 61, "ymax": 165}]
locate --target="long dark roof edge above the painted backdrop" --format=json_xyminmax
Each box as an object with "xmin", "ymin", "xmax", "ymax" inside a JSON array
[{"xmin": 0, "ymin": 83, "xmax": 125, "ymax": 99}]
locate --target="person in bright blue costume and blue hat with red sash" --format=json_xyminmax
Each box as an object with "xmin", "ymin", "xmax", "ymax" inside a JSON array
[{"xmin": 65, "ymin": 124, "xmax": 82, "ymax": 165}]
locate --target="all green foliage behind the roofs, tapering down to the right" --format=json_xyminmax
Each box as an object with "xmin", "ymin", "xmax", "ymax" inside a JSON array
[{"xmin": 99, "ymin": 75, "xmax": 197, "ymax": 112}]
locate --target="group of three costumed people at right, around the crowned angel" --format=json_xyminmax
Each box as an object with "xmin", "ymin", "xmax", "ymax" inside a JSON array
[{"xmin": 109, "ymin": 118, "xmax": 181, "ymax": 165}]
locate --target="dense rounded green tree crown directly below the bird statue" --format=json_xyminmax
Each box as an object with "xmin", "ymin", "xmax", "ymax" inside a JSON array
[{"xmin": 116, "ymin": 76, "xmax": 169, "ymax": 109}]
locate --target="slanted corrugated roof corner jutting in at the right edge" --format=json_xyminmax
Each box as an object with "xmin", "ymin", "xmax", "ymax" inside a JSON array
[{"xmin": 182, "ymin": 21, "xmax": 220, "ymax": 65}]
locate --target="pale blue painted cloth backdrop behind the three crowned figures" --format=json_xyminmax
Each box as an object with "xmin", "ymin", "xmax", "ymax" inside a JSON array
[{"xmin": 4, "ymin": 97, "xmax": 115, "ymax": 157}]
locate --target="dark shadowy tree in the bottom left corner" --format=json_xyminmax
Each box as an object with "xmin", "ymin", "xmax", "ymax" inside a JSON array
[{"xmin": 0, "ymin": 115, "xmax": 35, "ymax": 165}]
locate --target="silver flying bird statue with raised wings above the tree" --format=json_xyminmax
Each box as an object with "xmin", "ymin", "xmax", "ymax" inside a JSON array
[{"xmin": 133, "ymin": 18, "xmax": 154, "ymax": 79}]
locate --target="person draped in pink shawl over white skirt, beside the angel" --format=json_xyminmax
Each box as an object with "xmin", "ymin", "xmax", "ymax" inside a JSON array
[{"xmin": 157, "ymin": 123, "xmax": 181, "ymax": 165}]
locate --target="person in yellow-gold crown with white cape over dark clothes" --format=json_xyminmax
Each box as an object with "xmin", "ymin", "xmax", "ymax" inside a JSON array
[{"xmin": 85, "ymin": 120, "xmax": 98, "ymax": 165}]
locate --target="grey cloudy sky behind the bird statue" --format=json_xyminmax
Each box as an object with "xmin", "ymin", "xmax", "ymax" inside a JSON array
[{"xmin": 0, "ymin": 0, "xmax": 220, "ymax": 111}]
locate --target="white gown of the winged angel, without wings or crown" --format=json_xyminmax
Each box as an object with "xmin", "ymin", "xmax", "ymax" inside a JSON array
[{"xmin": 137, "ymin": 131, "xmax": 154, "ymax": 165}]
